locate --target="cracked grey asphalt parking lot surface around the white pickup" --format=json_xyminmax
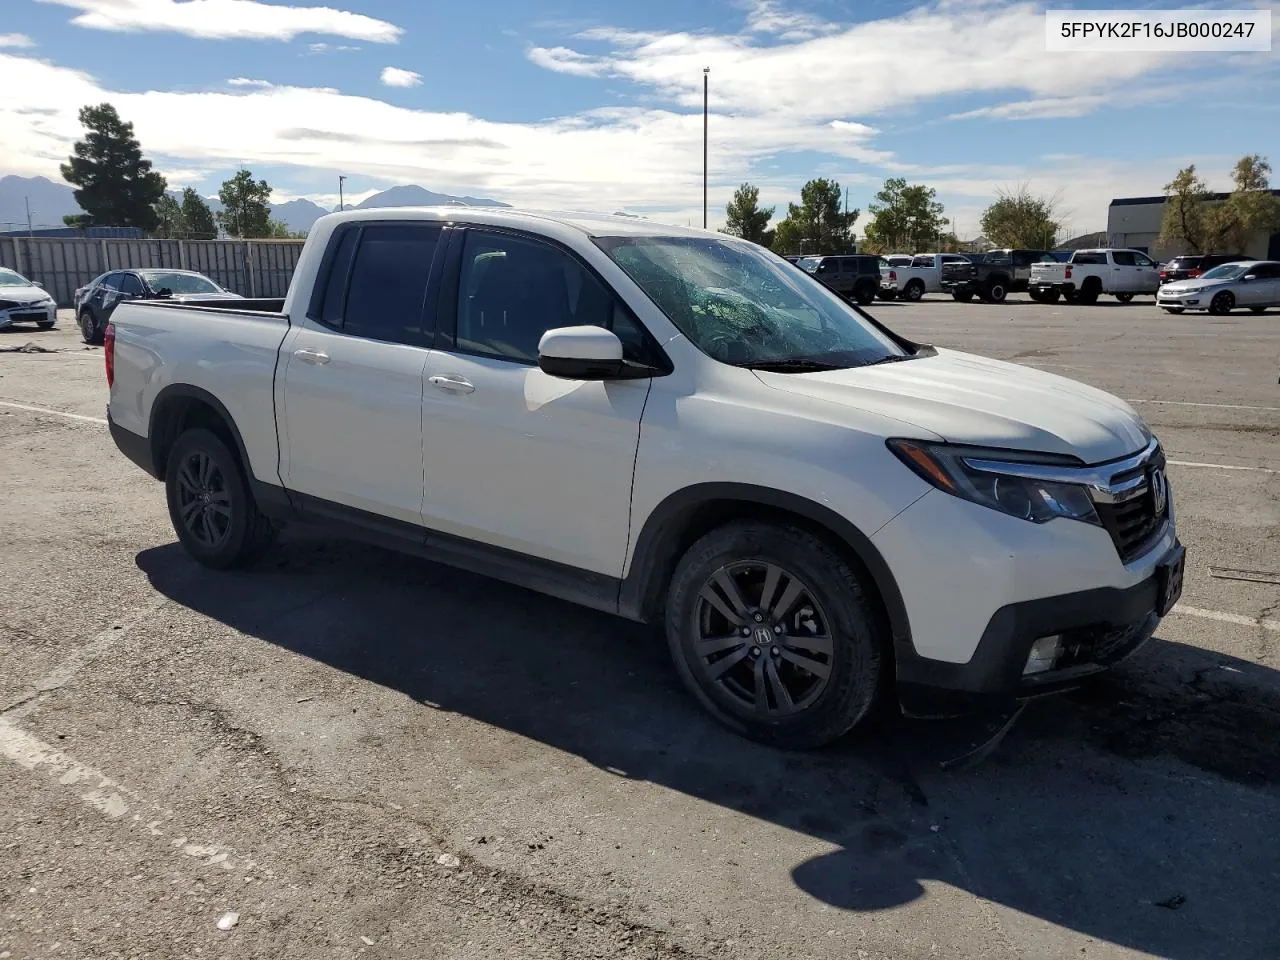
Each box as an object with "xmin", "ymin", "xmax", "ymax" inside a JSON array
[{"xmin": 0, "ymin": 296, "xmax": 1280, "ymax": 960}]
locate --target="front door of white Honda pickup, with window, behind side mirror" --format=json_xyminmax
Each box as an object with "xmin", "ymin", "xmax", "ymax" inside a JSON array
[{"xmin": 422, "ymin": 229, "xmax": 652, "ymax": 577}]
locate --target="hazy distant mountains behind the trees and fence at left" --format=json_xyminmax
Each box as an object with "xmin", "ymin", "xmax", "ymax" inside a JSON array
[{"xmin": 0, "ymin": 175, "xmax": 509, "ymax": 233}]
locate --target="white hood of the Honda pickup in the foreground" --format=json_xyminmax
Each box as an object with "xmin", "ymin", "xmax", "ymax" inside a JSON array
[{"xmin": 755, "ymin": 349, "xmax": 1149, "ymax": 463}]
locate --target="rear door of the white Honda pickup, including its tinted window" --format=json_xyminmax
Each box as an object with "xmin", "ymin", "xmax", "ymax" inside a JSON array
[{"xmin": 276, "ymin": 220, "xmax": 443, "ymax": 534}]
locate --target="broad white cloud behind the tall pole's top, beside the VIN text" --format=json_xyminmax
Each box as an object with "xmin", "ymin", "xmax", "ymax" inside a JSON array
[{"xmin": 530, "ymin": 0, "xmax": 1185, "ymax": 120}]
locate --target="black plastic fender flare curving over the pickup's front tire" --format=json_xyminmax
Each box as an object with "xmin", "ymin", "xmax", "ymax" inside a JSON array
[{"xmin": 618, "ymin": 483, "xmax": 914, "ymax": 653}]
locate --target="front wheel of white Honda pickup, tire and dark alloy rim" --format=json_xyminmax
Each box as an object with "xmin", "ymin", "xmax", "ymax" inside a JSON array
[{"xmin": 666, "ymin": 521, "xmax": 887, "ymax": 750}]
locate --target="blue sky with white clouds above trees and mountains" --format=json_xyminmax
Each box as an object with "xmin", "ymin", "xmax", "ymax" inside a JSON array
[{"xmin": 0, "ymin": 0, "xmax": 1280, "ymax": 236}]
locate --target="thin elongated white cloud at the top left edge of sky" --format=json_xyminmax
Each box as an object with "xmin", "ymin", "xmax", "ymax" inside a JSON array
[{"xmin": 40, "ymin": 0, "xmax": 404, "ymax": 44}]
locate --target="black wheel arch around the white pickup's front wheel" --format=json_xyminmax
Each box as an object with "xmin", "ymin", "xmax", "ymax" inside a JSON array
[{"xmin": 618, "ymin": 483, "xmax": 911, "ymax": 652}]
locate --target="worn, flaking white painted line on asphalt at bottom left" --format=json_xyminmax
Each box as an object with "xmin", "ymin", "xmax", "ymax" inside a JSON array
[{"xmin": 0, "ymin": 717, "xmax": 275, "ymax": 877}]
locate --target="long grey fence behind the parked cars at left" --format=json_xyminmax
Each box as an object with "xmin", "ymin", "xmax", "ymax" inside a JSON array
[{"xmin": 0, "ymin": 237, "xmax": 303, "ymax": 307}]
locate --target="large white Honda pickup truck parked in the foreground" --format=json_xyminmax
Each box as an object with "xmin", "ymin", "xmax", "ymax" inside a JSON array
[{"xmin": 105, "ymin": 207, "xmax": 1184, "ymax": 748}]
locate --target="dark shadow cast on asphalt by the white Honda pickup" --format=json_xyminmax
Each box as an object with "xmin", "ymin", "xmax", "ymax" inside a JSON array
[{"xmin": 137, "ymin": 531, "xmax": 1280, "ymax": 960}]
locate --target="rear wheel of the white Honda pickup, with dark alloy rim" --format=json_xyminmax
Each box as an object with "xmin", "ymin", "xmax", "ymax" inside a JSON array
[{"xmin": 165, "ymin": 429, "xmax": 275, "ymax": 570}]
